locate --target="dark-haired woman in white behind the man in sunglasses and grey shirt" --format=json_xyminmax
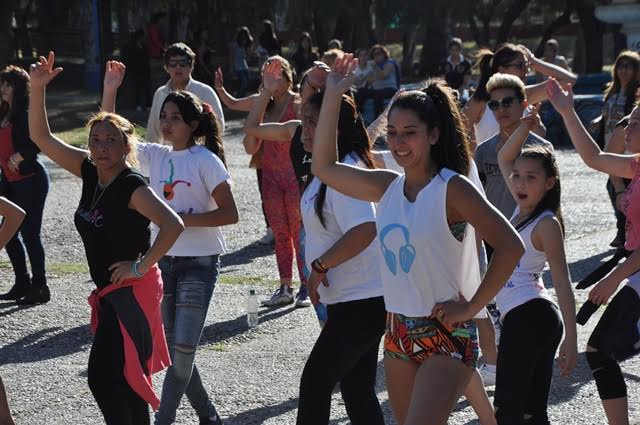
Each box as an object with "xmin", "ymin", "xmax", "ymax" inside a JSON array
[{"xmin": 462, "ymin": 43, "xmax": 576, "ymax": 150}]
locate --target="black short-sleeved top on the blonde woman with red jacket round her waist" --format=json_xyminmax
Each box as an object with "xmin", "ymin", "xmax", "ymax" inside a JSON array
[{"xmin": 74, "ymin": 159, "xmax": 151, "ymax": 288}]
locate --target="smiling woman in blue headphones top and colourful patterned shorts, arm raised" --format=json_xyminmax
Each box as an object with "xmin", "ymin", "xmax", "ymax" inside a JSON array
[{"xmin": 311, "ymin": 55, "xmax": 523, "ymax": 425}]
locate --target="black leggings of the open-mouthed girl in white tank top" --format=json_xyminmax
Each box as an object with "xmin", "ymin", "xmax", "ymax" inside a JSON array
[{"xmin": 493, "ymin": 298, "xmax": 562, "ymax": 425}]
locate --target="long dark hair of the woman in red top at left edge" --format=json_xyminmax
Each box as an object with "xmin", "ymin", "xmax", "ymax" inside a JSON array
[{"xmin": 0, "ymin": 65, "xmax": 31, "ymax": 151}]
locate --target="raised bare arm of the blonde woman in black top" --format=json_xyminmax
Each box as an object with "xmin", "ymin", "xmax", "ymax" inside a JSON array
[{"xmin": 29, "ymin": 52, "xmax": 89, "ymax": 177}]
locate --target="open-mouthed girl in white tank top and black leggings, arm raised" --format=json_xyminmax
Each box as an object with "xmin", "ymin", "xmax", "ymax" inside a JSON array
[{"xmin": 494, "ymin": 108, "xmax": 578, "ymax": 425}]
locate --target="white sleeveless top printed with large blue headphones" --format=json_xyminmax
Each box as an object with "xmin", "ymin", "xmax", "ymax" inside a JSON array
[{"xmin": 376, "ymin": 168, "xmax": 480, "ymax": 317}]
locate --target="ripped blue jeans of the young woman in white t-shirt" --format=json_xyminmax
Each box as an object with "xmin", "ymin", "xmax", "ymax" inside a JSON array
[{"xmin": 155, "ymin": 255, "xmax": 220, "ymax": 425}]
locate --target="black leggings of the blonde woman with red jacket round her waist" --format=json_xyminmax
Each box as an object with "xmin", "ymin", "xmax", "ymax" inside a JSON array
[{"xmin": 88, "ymin": 300, "xmax": 149, "ymax": 425}]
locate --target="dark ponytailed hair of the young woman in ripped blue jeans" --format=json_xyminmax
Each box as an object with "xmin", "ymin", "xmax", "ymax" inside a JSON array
[{"xmin": 160, "ymin": 91, "xmax": 227, "ymax": 167}]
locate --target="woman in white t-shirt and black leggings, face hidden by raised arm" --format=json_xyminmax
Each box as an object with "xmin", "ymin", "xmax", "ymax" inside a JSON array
[{"xmin": 297, "ymin": 93, "xmax": 385, "ymax": 425}]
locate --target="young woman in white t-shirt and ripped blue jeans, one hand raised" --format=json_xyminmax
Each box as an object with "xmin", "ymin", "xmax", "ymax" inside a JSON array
[{"xmin": 102, "ymin": 64, "xmax": 238, "ymax": 425}]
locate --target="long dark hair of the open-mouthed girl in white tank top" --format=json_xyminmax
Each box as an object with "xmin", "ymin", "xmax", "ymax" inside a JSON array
[{"xmin": 516, "ymin": 145, "xmax": 565, "ymax": 235}]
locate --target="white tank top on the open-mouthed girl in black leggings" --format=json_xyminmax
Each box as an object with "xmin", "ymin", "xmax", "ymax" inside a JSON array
[{"xmin": 496, "ymin": 207, "xmax": 554, "ymax": 321}]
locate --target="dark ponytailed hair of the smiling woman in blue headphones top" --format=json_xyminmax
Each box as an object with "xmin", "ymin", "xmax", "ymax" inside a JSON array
[{"xmin": 389, "ymin": 80, "xmax": 471, "ymax": 176}]
